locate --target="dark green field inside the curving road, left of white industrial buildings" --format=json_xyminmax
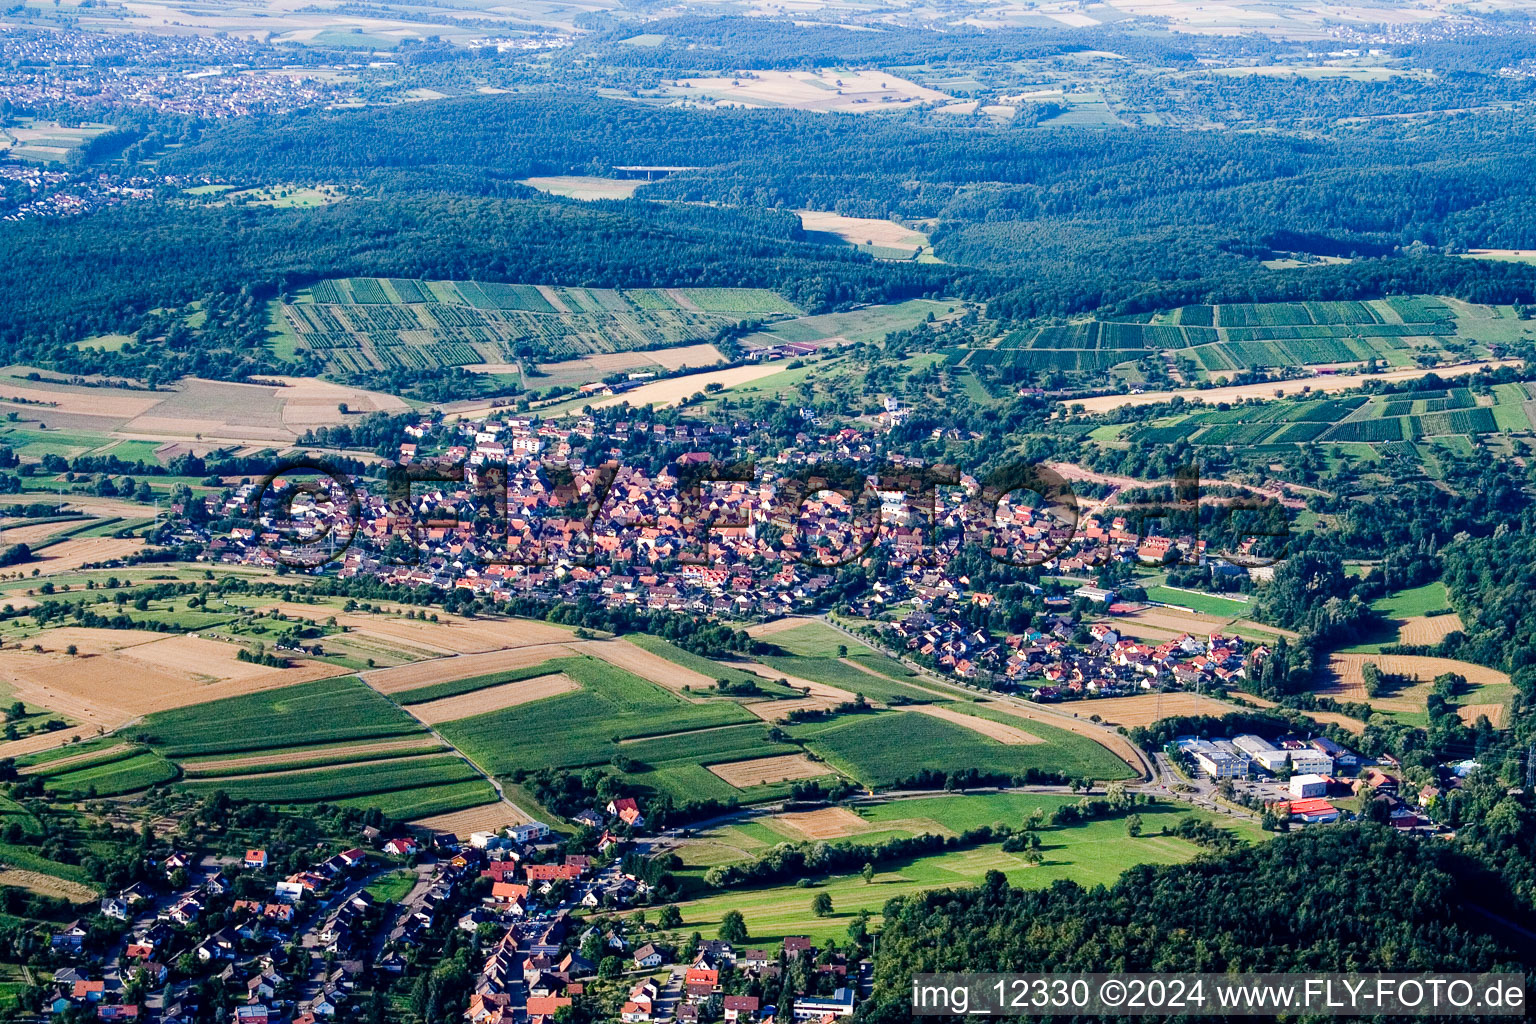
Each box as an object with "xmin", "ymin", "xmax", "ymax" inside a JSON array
[{"xmin": 790, "ymin": 711, "xmax": 1130, "ymax": 788}]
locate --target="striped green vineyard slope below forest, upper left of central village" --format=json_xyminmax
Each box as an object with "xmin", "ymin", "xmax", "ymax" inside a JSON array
[{"xmin": 281, "ymin": 278, "xmax": 800, "ymax": 378}]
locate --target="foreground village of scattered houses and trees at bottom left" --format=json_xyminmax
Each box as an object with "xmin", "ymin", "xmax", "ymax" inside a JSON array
[{"xmin": 36, "ymin": 797, "xmax": 872, "ymax": 1024}]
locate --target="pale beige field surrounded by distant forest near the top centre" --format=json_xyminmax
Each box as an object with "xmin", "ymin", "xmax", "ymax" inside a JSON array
[{"xmin": 664, "ymin": 71, "xmax": 951, "ymax": 111}]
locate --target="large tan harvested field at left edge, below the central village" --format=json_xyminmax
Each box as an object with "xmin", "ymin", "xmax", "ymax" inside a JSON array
[{"xmin": 0, "ymin": 626, "xmax": 347, "ymax": 727}]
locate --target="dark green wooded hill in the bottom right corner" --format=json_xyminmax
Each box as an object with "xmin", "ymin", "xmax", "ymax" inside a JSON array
[{"xmin": 865, "ymin": 824, "xmax": 1528, "ymax": 1024}]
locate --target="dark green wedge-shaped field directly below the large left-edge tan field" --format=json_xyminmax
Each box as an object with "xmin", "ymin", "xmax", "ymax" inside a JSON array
[{"xmin": 134, "ymin": 676, "xmax": 421, "ymax": 757}]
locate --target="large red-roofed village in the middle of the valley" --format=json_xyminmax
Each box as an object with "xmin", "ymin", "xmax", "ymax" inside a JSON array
[{"xmin": 210, "ymin": 402, "xmax": 1269, "ymax": 712}]
